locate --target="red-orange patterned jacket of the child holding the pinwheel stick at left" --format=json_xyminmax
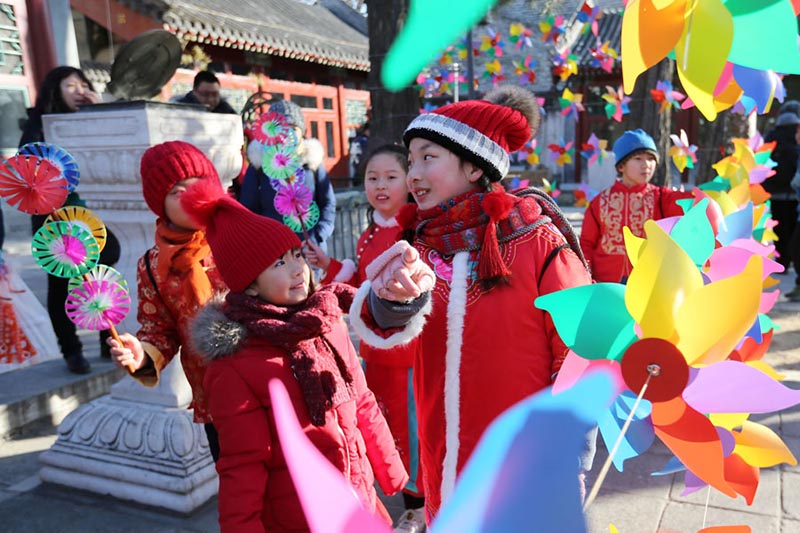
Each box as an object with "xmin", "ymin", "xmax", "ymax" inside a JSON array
[{"xmin": 134, "ymin": 246, "xmax": 227, "ymax": 424}]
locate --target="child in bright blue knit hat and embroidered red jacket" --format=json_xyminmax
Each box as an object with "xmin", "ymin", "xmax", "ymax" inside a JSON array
[{"xmin": 581, "ymin": 129, "xmax": 692, "ymax": 283}]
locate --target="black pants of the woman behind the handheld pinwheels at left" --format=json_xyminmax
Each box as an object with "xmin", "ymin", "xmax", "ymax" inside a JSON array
[{"xmin": 31, "ymin": 215, "xmax": 120, "ymax": 357}]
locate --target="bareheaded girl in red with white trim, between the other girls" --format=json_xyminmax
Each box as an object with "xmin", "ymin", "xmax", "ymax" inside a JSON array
[{"xmin": 304, "ymin": 144, "xmax": 425, "ymax": 532}]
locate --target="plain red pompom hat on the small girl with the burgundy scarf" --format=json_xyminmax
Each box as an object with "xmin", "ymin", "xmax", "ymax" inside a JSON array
[{"xmin": 181, "ymin": 180, "xmax": 300, "ymax": 292}]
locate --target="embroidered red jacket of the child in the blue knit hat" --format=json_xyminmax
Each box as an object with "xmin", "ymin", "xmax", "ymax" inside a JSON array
[{"xmin": 581, "ymin": 180, "xmax": 692, "ymax": 283}]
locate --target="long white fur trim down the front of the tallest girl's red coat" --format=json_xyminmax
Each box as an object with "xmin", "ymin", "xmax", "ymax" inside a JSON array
[{"xmin": 441, "ymin": 252, "xmax": 469, "ymax": 506}]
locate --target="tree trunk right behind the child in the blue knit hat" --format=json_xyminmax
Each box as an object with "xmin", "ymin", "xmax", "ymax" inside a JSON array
[{"xmin": 628, "ymin": 59, "xmax": 675, "ymax": 185}]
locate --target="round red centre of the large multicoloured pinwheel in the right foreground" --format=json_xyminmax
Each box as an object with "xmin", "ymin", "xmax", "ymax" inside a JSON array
[{"xmin": 622, "ymin": 339, "xmax": 689, "ymax": 402}]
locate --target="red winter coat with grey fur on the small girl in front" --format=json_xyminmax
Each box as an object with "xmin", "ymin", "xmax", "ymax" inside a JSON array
[{"xmin": 193, "ymin": 305, "xmax": 408, "ymax": 533}]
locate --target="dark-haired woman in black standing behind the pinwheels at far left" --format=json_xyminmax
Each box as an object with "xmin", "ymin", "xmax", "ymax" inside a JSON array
[{"xmin": 19, "ymin": 66, "xmax": 120, "ymax": 374}]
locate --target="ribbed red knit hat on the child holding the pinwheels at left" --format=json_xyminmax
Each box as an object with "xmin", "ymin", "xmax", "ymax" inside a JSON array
[{"xmin": 139, "ymin": 141, "xmax": 219, "ymax": 217}]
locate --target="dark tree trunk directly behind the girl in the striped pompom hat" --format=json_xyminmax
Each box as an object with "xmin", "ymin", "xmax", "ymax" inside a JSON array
[{"xmin": 367, "ymin": 0, "xmax": 420, "ymax": 151}]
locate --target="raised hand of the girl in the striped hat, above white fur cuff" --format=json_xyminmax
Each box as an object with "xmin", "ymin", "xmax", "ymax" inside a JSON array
[{"xmin": 366, "ymin": 241, "xmax": 434, "ymax": 302}]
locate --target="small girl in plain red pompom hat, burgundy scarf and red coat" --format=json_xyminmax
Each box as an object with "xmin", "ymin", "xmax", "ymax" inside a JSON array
[{"xmin": 182, "ymin": 183, "xmax": 408, "ymax": 532}]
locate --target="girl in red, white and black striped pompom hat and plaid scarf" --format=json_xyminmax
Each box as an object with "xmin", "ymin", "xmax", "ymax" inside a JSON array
[{"xmin": 350, "ymin": 87, "xmax": 591, "ymax": 519}]
